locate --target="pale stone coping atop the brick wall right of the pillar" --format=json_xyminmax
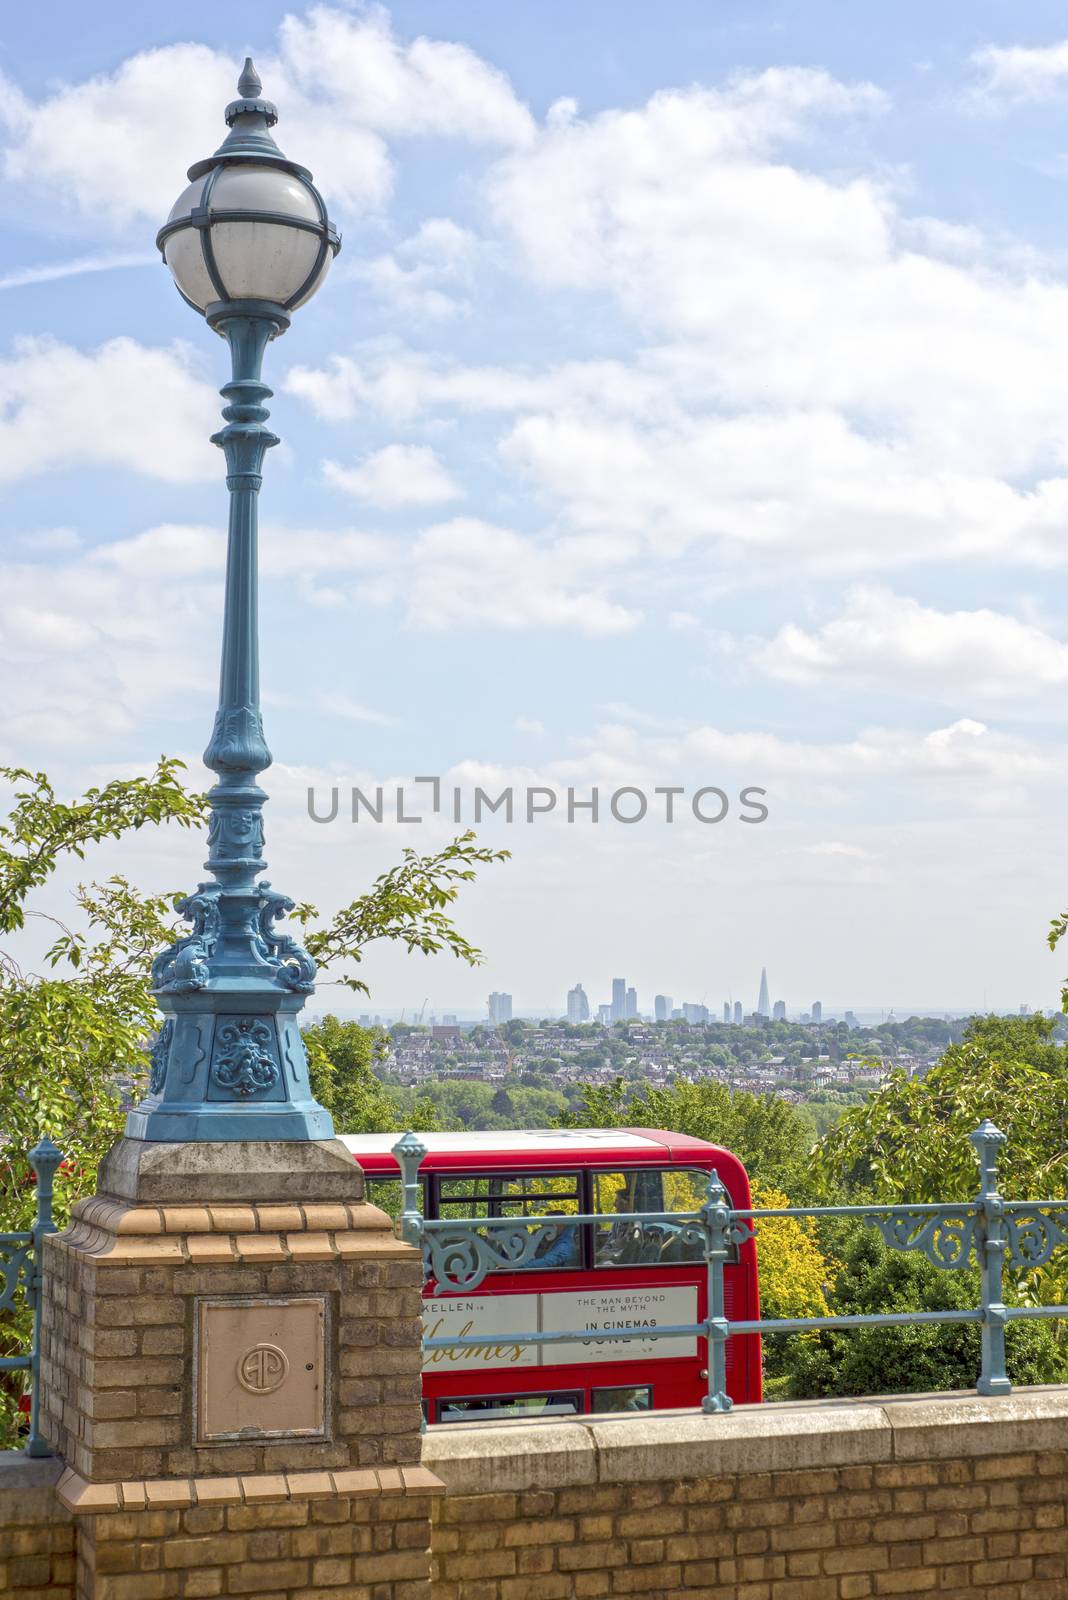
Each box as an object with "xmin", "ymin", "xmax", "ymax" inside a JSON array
[{"xmin": 422, "ymin": 1384, "xmax": 1068, "ymax": 1494}]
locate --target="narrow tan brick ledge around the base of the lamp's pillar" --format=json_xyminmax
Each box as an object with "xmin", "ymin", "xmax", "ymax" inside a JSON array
[{"xmin": 48, "ymin": 1467, "xmax": 444, "ymax": 1517}]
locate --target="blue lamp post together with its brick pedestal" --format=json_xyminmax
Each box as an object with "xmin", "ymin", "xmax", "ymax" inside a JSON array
[{"xmin": 42, "ymin": 62, "xmax": 441, "ymax": 1600}]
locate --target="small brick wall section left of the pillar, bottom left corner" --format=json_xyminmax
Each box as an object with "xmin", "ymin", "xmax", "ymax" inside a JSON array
[{"xmin": 0, "ymin": 1451, "xmax": 74, "ymax": 1600}]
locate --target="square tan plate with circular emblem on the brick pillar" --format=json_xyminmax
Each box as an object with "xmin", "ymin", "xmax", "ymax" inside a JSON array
[{"xmin": 193, "ymin": 1294, "xmax": 328, "ymax": 1445}]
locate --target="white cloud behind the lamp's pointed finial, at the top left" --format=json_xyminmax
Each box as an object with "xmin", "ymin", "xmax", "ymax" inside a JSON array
[{"xmin": 0, "ymin": 5, "xmax": 534, "ymax": 232}]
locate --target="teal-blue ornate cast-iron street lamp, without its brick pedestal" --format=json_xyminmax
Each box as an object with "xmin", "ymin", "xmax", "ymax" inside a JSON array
[{"xmin": 126, "ymin": 61, "xmax": 341, "ymax": 1142}]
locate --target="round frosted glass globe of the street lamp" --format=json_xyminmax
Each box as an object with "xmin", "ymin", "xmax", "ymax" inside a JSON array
[{"xmin": 163, "ymin": 162, "xmax": 333, "ymax": 310}]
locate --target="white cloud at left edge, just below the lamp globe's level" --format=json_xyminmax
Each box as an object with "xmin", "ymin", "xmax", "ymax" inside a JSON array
[{"xmin": 0, "ymin": 339, "xmax": 219, "ymax": 483}]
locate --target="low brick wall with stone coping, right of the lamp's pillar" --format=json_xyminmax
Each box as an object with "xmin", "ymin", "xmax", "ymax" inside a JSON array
[{"xmin": 424, "ymin": 1389, "xmax": 1068, "ymax": 1600}]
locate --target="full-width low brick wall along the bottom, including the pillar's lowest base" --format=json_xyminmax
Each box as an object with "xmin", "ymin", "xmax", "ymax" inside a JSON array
[{"xmin": 10, "ymin": 1389, "xmax": 1068, "ymax": 1600}]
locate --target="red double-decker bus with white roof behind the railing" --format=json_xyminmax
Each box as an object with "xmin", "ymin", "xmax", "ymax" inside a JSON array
[{"xmin": 342, "ymin": 1128, "xmax": 761, "ymax": 1422}]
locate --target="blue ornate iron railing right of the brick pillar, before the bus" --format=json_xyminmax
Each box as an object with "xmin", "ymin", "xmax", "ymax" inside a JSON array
[{"xmin": 393, "ymin": 1120, "xmax": 1068, "ymax": 1411}]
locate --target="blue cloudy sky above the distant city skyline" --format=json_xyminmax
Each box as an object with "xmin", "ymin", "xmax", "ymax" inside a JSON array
[{"xmin": 0, "ymin": 0, "xmax": 1068, "ymax": 1010}]
